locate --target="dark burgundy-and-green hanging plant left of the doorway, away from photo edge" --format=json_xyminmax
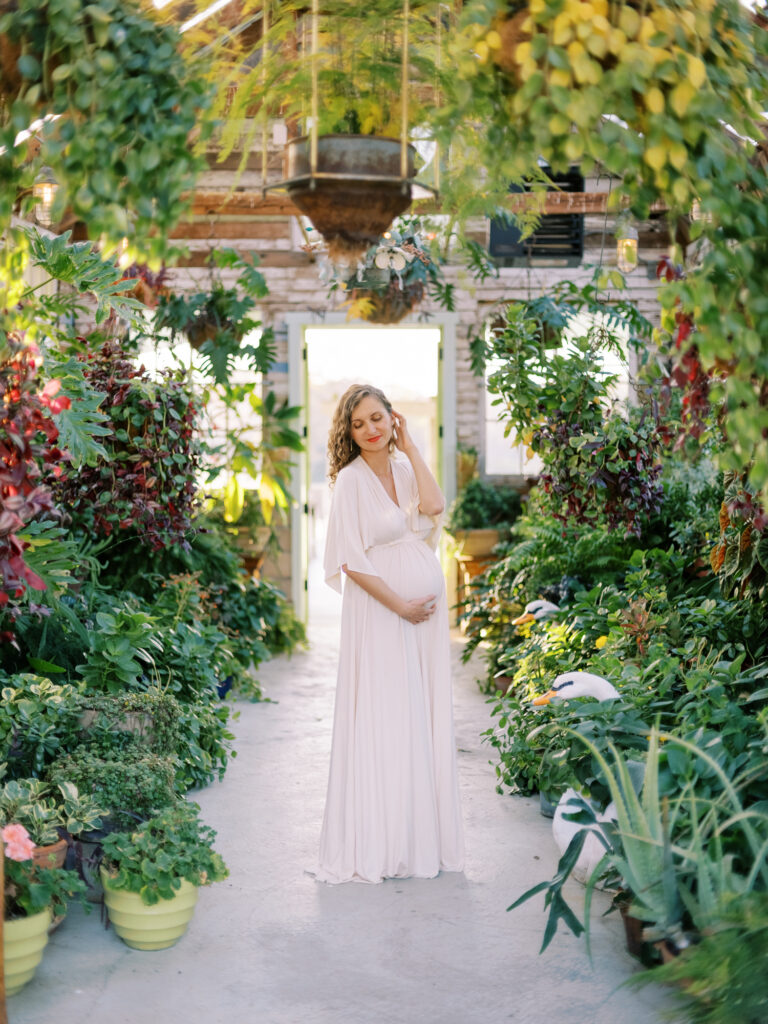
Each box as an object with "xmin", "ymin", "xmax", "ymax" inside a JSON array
[{"xmin": 54, "ymin": 341, "xmax": 200, "ymax": 551}]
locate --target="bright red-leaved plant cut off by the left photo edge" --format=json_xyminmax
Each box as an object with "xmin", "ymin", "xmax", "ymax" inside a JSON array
[{"xmin": 0, "ymin": 332, "xmax": 70, "ymax": 626}]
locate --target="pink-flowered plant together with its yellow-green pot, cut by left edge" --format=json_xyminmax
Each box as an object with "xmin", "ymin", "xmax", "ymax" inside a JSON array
[{"xmin": 0, "ymin": 822, "xmax": 85, "ymax": 995}]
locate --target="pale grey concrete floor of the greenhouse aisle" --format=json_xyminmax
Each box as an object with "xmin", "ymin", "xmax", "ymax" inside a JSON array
[{"xmin": 8, "ymin": 593, "xmax": 674, "ymax": 1024}]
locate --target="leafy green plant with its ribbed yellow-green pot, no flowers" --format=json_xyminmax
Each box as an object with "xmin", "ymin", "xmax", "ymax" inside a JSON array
[{"xmin": 101, "ymin": 802, "xmax": 229, "ymax": 949}]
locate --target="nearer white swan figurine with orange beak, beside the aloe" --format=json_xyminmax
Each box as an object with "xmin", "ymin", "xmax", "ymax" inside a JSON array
[{"xmin": 534, "ymin": 672, "xmax": 618, "ymax": 883}]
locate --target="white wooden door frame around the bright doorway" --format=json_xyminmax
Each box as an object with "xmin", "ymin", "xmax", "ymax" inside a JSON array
[{"xmin": 284, "ymin": 310, "xmax": 459, "ymax": 621}]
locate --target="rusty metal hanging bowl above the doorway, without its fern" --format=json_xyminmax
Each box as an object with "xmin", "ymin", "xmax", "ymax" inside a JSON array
[{"xmin": 274, "ymin": 135, "xmax": 416, "ymax": 258}]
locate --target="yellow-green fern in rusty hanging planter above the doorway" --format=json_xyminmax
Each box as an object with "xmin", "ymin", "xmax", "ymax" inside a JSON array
[{"xmin": 215, "ymin": 0, "xmax": 442, "ymax": 261}]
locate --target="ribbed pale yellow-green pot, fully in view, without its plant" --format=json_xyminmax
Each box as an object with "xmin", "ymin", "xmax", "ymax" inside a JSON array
[{"xmin": 101, "ymin": 867, "xmax": 198, "ymax": 949}]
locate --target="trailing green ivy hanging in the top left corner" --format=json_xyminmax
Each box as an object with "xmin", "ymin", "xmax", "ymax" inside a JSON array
[{"xmin": 0, "ymin": 0, "xmax": 211, "ymax": 258}]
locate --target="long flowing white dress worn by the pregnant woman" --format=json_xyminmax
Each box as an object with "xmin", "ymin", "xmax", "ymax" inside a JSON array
[{"xmin": 316, "ymin": 453, "xmax": 464, "ymax": 883}]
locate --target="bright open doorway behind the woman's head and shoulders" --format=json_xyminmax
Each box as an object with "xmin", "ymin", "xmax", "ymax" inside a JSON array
[{"xmin": 304, "ymin": 325, "xmax": 441, "ymax": 624}]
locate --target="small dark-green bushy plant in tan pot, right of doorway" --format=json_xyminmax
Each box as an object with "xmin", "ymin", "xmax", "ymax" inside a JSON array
[{"xmin": 445, "ymin": 477, "xmax": 520, "ymax": 559}]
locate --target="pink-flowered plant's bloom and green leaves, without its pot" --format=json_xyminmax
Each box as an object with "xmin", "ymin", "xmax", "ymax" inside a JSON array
[{"xmin": 0, "ymin": 823, "xmax": 85, "ymax": 921}]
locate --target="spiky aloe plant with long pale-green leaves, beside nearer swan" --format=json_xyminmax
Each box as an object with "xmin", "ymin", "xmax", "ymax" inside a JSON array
[{"xmin": 508, "ymin": 729, "xmax": 768, "ymax": 952}]
